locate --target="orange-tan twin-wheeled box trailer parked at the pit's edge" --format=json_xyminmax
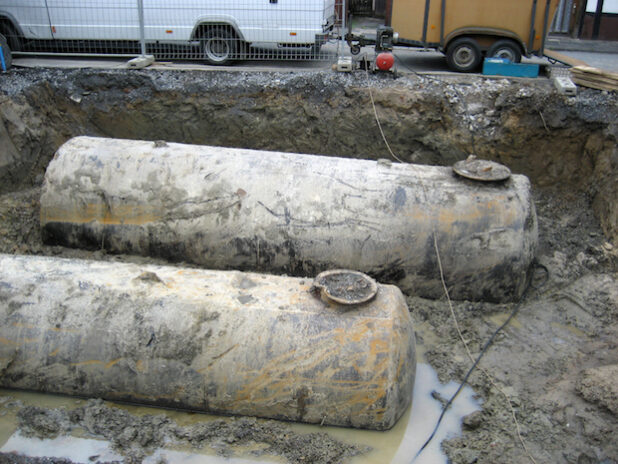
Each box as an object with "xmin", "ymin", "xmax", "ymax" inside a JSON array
[{"xmin": 386, "ymin": 0, "xmax": 560, "ymax": 72}]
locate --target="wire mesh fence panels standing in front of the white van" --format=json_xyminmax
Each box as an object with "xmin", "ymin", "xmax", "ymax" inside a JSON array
[{"xmin": 0, "ymin": 0, "xmax": 346, "ymax": 64}]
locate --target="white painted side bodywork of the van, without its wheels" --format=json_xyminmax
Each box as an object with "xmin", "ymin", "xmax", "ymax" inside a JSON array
[{"xmin": 0, "ymin": 0, "xmax": 335, "ymax": 44}]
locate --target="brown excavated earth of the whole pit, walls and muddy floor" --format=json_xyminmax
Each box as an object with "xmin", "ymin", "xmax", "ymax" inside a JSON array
[{"xmin": 0, "ymin": 71, "xmax": 618, "ymax": 464}]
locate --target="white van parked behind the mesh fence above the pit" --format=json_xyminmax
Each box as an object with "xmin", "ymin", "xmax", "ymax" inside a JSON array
[{"xmin": 0, "ymin": 0, "xmax": 336, "ymax": 64}]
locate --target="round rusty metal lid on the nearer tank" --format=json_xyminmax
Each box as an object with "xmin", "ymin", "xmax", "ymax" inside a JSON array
[{"xmin": 311, "ymin": 269, "xmax": 378, "ymax": 305}]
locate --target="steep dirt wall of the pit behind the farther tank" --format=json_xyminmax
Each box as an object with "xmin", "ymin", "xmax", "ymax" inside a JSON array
[{"xmin": 0, "ymin": 70, "xmax": 618, "ymax": 240}]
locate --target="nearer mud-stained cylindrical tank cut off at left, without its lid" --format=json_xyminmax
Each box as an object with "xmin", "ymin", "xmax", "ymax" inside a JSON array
[{"xmin": 0, "ymin": 255, "xmax": 416, "ymax": 430}]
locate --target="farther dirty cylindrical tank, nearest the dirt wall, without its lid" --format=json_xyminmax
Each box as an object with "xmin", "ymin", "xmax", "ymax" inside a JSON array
[{"xmin": 41, "ymin": 137, "xmax": 537, "ymax": 302}]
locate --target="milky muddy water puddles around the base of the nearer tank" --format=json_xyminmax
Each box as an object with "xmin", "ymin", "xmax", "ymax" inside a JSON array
[{"xmin": 0, "ymin": 363, "xmax": 480, "ymax": 464}]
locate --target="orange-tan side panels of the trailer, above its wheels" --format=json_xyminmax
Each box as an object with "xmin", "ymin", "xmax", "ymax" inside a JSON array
[{"xmin": 391, "ymin": 0, "xmax": 559, "ymax": 51}]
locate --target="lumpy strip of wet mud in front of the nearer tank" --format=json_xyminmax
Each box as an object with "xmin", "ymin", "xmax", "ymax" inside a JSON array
[{"xmin": 10, "ymin": 400, "xmax": 365, "ymax": 463}]
